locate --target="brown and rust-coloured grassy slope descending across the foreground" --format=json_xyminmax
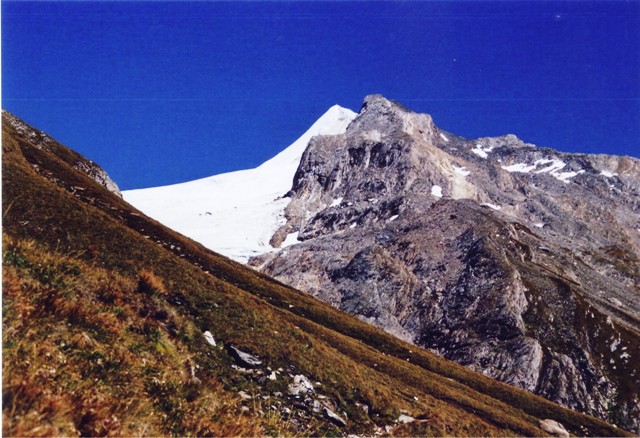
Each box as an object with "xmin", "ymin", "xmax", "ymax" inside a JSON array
[{"xmin": 3, "ymin": 117, "xmax": 622, "ymax": 436}]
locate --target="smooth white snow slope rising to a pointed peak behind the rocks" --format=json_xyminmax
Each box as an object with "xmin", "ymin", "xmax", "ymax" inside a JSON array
[{"xmin": 122, "ymin": 105, "xmax": 356, "ymax": 262}]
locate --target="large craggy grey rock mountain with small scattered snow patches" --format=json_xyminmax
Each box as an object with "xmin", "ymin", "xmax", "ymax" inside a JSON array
[{"xmin": 252, "ymin": 96, "xmax": 640, "ymax": 432}]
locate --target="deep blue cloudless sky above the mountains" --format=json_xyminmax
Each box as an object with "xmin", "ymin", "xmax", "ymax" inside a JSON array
[{"xmin": 2, "ymin": 0, "xmax": 640, "ymax": 189}]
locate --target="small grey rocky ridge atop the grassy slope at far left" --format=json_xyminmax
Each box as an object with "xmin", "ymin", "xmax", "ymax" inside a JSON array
[{"xmin": 2, "ymin": 110, "xmax": 122, "ymax": 197}]
